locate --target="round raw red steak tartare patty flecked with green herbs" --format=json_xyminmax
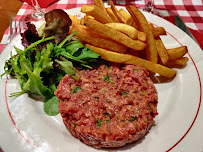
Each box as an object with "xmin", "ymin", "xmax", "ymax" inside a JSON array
[{"xmin": 55, "ymin": 65, "xmax": 158, "ymax": 148}]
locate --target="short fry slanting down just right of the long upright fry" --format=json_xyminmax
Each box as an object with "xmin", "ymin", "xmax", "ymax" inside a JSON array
[{"xmin": 155, "ymin": 38, "xmax": 169, "ymax": 65}]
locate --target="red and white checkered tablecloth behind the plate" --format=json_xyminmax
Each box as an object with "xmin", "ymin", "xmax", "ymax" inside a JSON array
[{"xmin": 0, "ymin": 0, "xmax": 203, "ymax": 53}]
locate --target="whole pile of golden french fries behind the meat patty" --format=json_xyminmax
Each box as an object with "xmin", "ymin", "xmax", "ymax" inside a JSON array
[{"xmin": 69, "ymin": 0, "xmax": 188, "ymax": 78}]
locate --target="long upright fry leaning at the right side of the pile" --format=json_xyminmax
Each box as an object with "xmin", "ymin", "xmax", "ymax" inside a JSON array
[{"xmin": 126, "ymin": 5, "xmax": 158, "ymax": 63}]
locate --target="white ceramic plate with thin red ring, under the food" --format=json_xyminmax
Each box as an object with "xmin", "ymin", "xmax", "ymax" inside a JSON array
[{"xmin": 0, "ymin": 8, "xmax": 203, "ymax": 152}]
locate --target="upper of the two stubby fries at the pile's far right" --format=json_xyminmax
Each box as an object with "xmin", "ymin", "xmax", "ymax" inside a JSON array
[{"xmin": 167, "ymin": 46, "xmax": 188, "ymax": 60}]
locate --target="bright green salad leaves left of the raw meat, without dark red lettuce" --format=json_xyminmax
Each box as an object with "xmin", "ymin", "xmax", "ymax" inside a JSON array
[{"xmin": 2, "ymin": 8, "xmax": 100, "ymax": 116}]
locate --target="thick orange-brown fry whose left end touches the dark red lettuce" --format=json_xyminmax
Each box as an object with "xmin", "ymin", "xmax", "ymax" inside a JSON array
[{"xmin": 69, "ymin": 25, "xmax": 127, "ymax": 53}]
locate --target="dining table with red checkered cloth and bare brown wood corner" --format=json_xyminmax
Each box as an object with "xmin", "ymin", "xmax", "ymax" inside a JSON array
[{"xmin": 0, "ymin": 0, "xmax": 203, "ymax": 53}]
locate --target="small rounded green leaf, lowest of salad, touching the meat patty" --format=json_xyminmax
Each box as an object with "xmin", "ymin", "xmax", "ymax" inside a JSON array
[{"xmin": 43, "ymin": 96, "xmax": 59, "ymax": 116}]
